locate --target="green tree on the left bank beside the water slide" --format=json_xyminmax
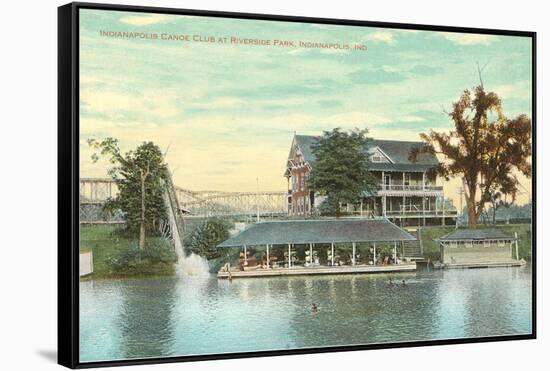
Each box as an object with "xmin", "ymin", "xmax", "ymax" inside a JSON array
[{"xmin": 88, "ymin": 138, "xmax": 168, "ymax": 249}]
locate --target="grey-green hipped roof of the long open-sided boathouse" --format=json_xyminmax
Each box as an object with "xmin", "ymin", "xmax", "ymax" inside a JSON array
[{"xmin": 218, "ymin": 219, "xmax": 415, "ymax": 247}]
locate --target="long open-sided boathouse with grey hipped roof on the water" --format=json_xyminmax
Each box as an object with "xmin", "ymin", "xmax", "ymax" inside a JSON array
[{"xmin": 218, "ymin": 218, "xmax": 416, "ymax": 278}]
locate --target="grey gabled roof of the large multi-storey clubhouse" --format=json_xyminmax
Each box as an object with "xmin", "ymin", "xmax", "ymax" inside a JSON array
[{"xmin": 289, "ymin": 135, "xmax": 439, "ymax": 171}]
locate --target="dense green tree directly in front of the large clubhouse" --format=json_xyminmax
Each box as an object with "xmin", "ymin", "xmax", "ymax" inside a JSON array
[{"xmin": 308, "ymin": 128, "xmax": 379, "ymax": 216}]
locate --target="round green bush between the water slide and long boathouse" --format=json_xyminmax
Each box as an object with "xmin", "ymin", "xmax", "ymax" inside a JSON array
[{"xmin": 188, "ymin": 218, "xmax": 231, "ymax": 259}]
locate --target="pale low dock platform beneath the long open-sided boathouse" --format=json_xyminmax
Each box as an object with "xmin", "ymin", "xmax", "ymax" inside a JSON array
[{"xmin": 218, "ymin": 262, "xmax": 416, "ymax": 278}]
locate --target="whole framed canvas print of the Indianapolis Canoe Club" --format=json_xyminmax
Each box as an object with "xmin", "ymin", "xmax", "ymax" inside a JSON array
[{"xmin": 58, "ymin": 3, "xmax": 536, "ymax": 368}]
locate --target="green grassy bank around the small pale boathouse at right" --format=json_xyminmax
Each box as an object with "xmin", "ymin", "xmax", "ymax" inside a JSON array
[{"xmin": 420, "ymin": 224, "xmax": 531, "ymax": 261}]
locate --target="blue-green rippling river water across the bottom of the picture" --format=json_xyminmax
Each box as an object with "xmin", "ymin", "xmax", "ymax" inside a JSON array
[{"xmin": 80, "ymin": 266, "xmax": 532, "ymax": 362}]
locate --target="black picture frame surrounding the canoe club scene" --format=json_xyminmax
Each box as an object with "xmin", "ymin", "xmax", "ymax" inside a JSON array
[{"xmin": 58, "ymin": 2, "xmax": 537, "ymax": 368}]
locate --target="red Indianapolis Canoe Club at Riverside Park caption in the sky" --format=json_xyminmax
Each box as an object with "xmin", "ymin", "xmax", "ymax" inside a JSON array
[{"xmin": 99, "ymin": 30, "xmax": 367, "ymax": 51}]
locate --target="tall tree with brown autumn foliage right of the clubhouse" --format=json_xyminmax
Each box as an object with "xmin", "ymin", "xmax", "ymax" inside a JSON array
[{"xmin": 410, "ymin": 84, "xmax": 532, "ymax": 228}]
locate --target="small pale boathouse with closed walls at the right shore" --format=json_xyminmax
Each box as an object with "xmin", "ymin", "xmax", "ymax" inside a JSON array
[{"xmin": 438, "ymin": 229, "xmax": 525, "ymax": 268}]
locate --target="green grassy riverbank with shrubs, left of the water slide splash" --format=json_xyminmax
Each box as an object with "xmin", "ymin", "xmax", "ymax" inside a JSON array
[{"xmin": 80, "ymin": 225, "xmax": 176, "ymax": 280}]
